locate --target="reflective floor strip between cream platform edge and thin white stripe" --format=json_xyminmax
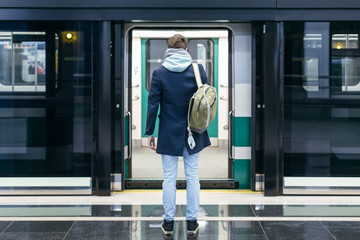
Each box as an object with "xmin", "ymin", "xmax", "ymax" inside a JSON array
[{"xmin": 0, "ymin": 204, "xmax": 360, "ymax": 218}]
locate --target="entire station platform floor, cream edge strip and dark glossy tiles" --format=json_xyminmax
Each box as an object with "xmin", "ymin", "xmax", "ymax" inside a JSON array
[{"xmin": 0, "ymin": 190, "xmax": 360, "ymax": 240}]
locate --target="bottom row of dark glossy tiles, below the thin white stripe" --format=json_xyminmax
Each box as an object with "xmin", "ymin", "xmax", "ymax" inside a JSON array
[{"xmin": 0, "ymin": 221, "xmax": 360, "ymax": 240}]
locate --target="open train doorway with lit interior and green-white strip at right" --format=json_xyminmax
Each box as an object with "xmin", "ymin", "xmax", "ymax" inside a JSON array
[{"xmin": 114, "ymin": 23, "xmax": 251, "ymax": 189}]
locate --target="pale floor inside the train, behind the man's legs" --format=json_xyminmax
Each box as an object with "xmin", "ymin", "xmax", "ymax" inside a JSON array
[{"xmin": 132, "ymin": 147, "xmax": 228, "ymax": 178}]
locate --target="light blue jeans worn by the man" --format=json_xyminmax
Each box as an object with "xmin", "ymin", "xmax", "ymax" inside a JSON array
[{"xmin": 161, "ymin": 147, "xmax": 200, "ymax": 221}]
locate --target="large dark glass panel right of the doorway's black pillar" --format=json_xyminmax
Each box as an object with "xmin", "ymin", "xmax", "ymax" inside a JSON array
[{"xmin": 283, "ymin": 22, "xmax": 360, "ymax": 181}]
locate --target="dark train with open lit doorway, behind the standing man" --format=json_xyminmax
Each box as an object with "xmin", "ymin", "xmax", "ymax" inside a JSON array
[{"xmin": 0, "ymin": 0, "xmax": 360, "ymax": 196}]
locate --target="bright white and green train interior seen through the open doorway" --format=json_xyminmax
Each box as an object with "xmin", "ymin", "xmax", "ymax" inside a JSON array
[{"xmin": 131, "ymin": 29, "xmax": 229, "ymax": 179}]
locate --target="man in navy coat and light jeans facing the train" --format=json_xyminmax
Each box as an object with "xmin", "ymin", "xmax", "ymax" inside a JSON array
[{"xmin": 145, "ymin": 34, "xmax": 210, "ymax": 236}]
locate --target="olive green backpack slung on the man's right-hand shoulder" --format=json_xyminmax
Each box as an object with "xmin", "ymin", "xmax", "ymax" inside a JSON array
[{"xmin": 188, "ymin": 63, "xmax": 216, "ymax": 149}]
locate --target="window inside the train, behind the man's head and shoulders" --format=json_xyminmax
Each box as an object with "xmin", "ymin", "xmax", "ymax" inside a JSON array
[{"xmin": 145, "ymin": 39, "xmax": 214, "ymax": 91}]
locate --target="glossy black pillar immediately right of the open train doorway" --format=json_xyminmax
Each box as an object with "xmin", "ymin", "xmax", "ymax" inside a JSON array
[{"xmin": 251, "ymin": 22, "xmax": 284, "ymax": 196}]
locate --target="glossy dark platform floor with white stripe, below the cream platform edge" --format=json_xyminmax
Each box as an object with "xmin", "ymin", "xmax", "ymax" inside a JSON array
[{"xmin": 0, "ymin": 204, "xmax": 360, "ymax": 240}]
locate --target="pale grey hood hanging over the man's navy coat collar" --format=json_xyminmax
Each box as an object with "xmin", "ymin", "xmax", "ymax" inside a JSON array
[{"xmin": 162, "ymin": 48, "xmax": 192, "ymax": 72}]
